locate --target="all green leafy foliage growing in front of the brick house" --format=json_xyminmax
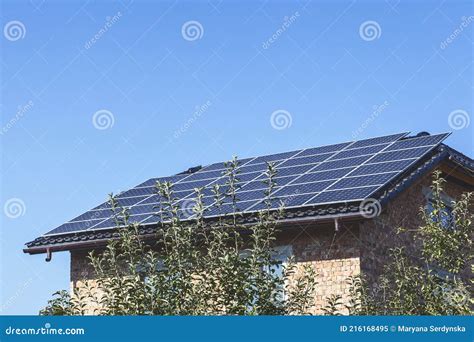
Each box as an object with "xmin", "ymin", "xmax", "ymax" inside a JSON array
[{"xmin": 40, "ymin": 167, "xmax": 474, "ymax": 315}]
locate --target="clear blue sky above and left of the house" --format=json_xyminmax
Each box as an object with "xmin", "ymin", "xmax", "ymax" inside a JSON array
[{"xmin": 0, "ymin": 0, "xmax": 474, "ymax": 314}]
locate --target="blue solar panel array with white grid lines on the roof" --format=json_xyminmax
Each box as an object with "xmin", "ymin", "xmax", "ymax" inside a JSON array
[{"xmin": 45, "ymin": 133, "xmax": 449, "ymax": 236}]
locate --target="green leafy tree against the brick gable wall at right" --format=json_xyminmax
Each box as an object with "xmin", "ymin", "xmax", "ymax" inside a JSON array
[{"xmin": 340, "ymin": 171, "xmax": 474, "ymax": 315}]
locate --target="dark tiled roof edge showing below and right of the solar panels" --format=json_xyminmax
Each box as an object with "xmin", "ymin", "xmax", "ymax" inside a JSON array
[{"xmin": 23, "ymin": 144, "xmax": 474, "ymax": 255}]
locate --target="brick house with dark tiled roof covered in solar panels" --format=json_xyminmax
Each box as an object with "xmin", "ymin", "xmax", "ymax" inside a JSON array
[{"xmin": 24, "ymin": 132, "xmax": 474, "ymax": 313}]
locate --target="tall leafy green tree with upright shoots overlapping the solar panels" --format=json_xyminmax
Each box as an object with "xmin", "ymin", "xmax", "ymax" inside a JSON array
[{"xmin": 41, "ymin": 158, "xmax": 316, "ymax": 315}]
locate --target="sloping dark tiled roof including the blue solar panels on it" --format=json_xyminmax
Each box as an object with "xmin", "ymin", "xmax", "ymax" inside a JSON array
[{"xmin": 25, "ymin": 133, "xmax": 474, "ymax": 253}]
